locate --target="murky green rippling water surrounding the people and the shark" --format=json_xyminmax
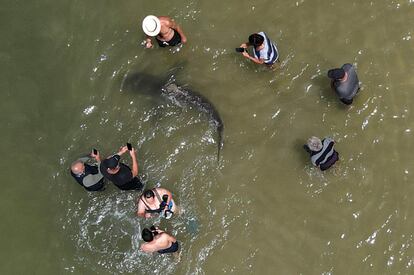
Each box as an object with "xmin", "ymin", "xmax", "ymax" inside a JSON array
[{"xmin": 0, "ymin": 0, "xmax": 414, "ymax": 274}]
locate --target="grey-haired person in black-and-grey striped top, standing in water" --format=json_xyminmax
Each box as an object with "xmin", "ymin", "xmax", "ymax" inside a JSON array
[{"xmin": 303, "ymin": 137, "xmax": 339, "ymax": 171}]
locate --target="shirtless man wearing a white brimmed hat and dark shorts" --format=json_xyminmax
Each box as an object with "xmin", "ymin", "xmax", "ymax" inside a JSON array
[{"xmin": 142, "ymin": 15, "xmax": 187, "ymax": 48}]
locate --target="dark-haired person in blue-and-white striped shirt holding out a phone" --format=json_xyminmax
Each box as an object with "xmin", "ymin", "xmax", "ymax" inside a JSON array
[{"xmin": 240, "ymin": 32, "xmax": 279, "ymax": 66}]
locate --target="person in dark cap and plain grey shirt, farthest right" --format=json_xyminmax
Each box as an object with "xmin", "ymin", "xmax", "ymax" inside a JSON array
[{"xmin": 328, "ymin": 63, "xmax": 359, "ymax": 105}]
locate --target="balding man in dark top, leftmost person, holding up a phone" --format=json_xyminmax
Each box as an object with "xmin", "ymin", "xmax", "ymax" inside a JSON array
[{"xmin": 70, "ymin": 149, "xmax": 104, "ymax": 191}]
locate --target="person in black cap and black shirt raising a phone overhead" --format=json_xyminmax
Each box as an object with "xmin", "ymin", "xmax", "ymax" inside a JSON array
[{"xmin": 99, "ymin": 145, "xmax": 144, "ymax": 190}]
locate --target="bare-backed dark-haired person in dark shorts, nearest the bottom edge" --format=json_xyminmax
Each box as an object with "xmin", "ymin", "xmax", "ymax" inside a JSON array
[{"xmin": 141, "ymin": 226, "xmax": 180, "ymax": 254}]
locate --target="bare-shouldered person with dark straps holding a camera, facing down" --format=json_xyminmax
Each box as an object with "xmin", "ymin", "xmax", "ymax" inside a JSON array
[{"xmin": 137, "ymin": 188, "xmax": 177, "ymax": 219}]
